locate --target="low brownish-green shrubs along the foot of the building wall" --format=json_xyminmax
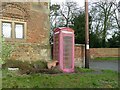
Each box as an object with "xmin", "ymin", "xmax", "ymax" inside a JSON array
[{"xmin": 3, "ymin": 60, "xmax": 61, "ymax": 74}]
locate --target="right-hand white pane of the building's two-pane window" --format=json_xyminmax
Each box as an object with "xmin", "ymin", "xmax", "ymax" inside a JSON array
[{"xmin": 15, "ymin": 24, "xmax": 24, "ymax": 39}]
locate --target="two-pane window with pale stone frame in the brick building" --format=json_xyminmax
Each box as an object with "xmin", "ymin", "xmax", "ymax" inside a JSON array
[{"xmin": 0, "ymin": 19, "xmax": 26, "ymax": 40}]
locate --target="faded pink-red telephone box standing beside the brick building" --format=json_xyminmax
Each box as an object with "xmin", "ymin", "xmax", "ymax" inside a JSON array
[{"xmin": 53, "ymin": 27, "xmax": 74, "ymax": 72}]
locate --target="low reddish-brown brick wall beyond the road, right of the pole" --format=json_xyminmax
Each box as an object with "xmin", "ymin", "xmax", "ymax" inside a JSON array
[{"xmin": 90, "ymin": 48, "xmax": 120, "ymax": 58}]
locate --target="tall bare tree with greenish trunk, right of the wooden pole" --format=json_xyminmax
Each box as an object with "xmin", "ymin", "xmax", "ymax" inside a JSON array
[{"xmin": 90, "ymin": 0, "xmax": 119, "ymax": 47}]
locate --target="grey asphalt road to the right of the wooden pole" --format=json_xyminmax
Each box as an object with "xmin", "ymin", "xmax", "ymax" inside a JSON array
[{"xmin": 89, "ymin": 60, "xmax": 120, "ymax": 72}]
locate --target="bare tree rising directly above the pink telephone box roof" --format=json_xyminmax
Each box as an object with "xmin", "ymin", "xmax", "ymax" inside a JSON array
[{"xmin": 60, "ymin": 2, "xmax": 80, "ymax": 27}]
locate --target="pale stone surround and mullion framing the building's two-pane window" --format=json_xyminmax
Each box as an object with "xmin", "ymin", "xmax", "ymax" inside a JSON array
[{"xmin": 0, "ymin": 19, "xmax": 27, "ymax": 42}]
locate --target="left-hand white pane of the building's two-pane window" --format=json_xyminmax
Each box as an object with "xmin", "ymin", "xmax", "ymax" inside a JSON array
[{"xmin": 2, "ymin": 22, "xmax": 12, "ymax": 38}]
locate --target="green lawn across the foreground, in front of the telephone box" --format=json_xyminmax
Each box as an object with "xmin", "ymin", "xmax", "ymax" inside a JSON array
[{"xmin": 2, "ymin": 68, "xmax": 118, "ymax": 88}]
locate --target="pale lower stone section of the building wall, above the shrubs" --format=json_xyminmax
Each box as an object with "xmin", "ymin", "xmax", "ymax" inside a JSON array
[{"xmin": 10, "ymin": 43, "xmax": 51, "ymax": 62}]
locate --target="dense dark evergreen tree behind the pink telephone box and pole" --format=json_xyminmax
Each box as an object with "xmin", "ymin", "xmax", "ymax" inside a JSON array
[{"xmin": 70, "ymin": 12, "xmax": 91, "ymax": 44}]
